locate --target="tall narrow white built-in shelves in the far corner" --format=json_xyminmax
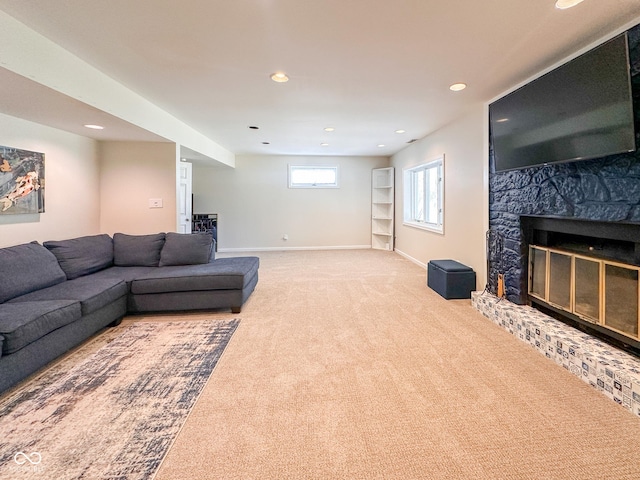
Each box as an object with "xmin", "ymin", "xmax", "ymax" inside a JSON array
[{"xmin": 371, "ymin": 167, "xmax": 395, "ymax": 251}]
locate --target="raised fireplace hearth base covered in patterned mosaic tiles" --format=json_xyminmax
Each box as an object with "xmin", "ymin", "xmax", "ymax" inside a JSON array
[{"xmin": 471, "ymin": 292, "xmax": 640, "ymax": 416}]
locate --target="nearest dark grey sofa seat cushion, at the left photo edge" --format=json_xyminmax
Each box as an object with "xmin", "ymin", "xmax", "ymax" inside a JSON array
[{"xmin": 0, "ymin": 300, "xmax": 82, "ymax": 355}]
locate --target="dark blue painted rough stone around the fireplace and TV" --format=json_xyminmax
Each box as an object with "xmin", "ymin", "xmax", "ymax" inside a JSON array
[{"xmin": 488, "ymin": 25, "xmax": 640, "ymax": 304}]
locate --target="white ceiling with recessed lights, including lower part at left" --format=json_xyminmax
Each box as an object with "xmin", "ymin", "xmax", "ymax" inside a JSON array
[{"xmin": 0, "ymin": 0, "xmax": 640, "ymax": 156}]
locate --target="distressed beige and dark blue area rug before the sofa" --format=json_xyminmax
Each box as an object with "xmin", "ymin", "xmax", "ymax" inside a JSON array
[{"xmin": 0, "ymin": 319, "xmax": 240, "ymax": 480}]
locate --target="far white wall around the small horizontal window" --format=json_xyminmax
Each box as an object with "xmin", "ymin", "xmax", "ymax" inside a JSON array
[{"xmin": 193, "ymin": 155, "xmax": 389, "ymax": 251}]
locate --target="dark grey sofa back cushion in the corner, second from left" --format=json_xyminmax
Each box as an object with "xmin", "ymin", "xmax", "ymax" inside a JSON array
[{"xmin": 44, "ymin": 234, "xmax": 113, "ymax": 280}]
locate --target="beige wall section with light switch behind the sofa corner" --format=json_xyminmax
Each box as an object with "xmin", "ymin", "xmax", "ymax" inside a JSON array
[{"xmin": 100, "ymin": 142, "xmax": 177, "ymax": 235}]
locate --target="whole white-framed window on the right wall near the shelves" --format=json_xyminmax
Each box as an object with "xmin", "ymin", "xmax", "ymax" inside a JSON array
[{"xmin": 403, "ymin": 156, "xmax": 444, "ymax": 232}]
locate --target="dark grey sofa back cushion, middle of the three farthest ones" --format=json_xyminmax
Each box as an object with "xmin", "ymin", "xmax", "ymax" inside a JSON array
[{"xmin": 113, "ymin": 233, "xmax": 165, "ymax": 267}]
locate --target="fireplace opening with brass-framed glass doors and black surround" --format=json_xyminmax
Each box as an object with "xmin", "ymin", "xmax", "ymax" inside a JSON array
[{"xmin": 520, "ymin": 216, "xmax": 640, "ymax": 357}]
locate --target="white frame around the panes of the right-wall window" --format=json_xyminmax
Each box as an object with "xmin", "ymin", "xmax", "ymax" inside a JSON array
[{"xmin": 402, "ymin": 154, "xmax": 444, "ymax": 234}]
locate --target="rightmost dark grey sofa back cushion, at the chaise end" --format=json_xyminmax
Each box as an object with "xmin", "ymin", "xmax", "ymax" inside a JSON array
[{"xmin": 159, "ymin": 232, "xmax": 213, "ymax": 267}]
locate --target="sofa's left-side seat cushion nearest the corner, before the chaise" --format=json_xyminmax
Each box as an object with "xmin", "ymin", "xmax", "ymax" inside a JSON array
[{"xmin": 10, "ymin": 275, "xmax": 127, "ymax": 315}]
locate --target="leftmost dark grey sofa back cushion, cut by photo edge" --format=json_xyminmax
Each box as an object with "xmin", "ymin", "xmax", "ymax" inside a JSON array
[{"xmin": 0, "ymin": 242, "xmax": 66, "ymax": 303}]
